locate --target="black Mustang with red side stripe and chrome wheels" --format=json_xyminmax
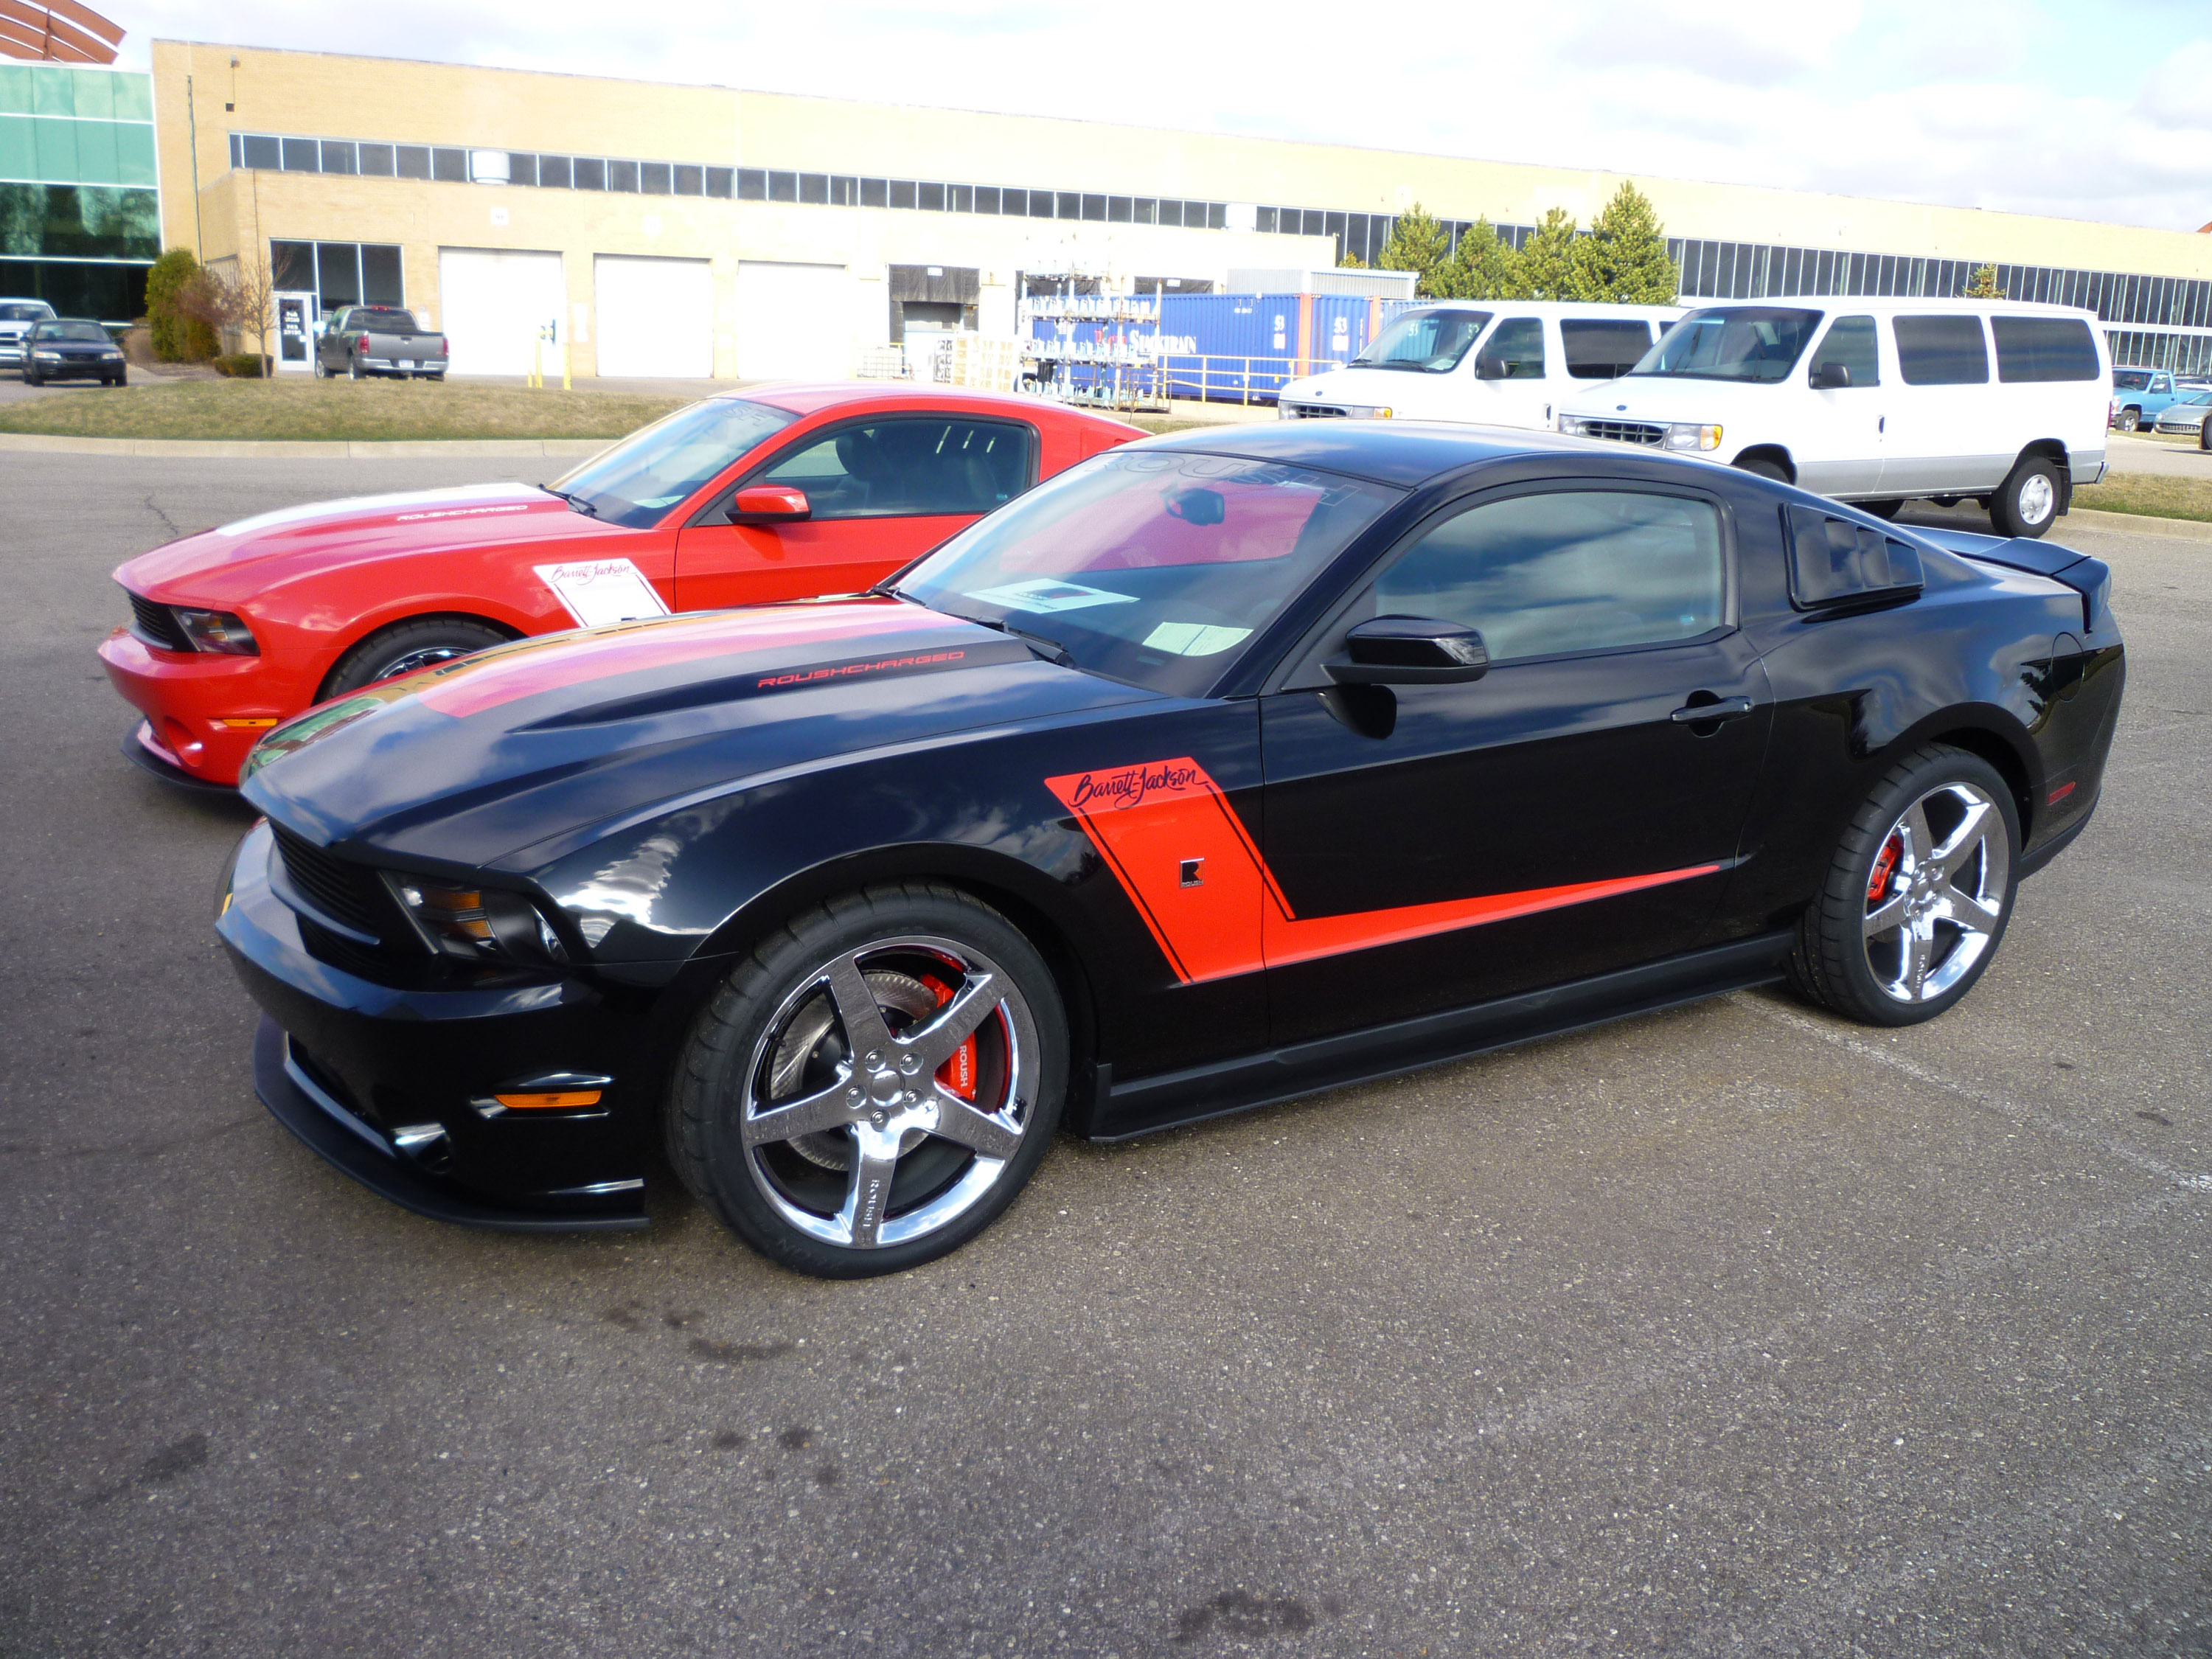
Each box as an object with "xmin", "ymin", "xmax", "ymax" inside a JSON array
[{"xmin": 219, "ymin": 420, "xmax": 2124, "ymax": 1274}]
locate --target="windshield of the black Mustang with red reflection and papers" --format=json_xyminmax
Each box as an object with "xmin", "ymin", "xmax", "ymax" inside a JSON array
[{"xmin": 898, "ymin": 449, "xmax": 1398, "ymax": 697}]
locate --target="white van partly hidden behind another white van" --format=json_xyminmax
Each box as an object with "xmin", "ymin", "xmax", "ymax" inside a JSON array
[{"xmin": 1276, "ymin": 299, "xmax": 1681, "ymax": 429}]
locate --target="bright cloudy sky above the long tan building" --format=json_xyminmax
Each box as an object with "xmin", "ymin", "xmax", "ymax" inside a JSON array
[{"xmin": 104, "ymin": 0, "xmax": 2212, "ymax": 230}]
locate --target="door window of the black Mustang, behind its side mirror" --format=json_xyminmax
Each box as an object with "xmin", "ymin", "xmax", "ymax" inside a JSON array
[{"xmin": 1374, "ymin": 489, "xmax": 1728, "ymax": 661}]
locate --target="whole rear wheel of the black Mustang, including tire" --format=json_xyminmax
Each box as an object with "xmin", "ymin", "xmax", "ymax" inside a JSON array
[{"xmin": 1790, "ymin": 743, "xmax": 2020, "ymax": 1026}]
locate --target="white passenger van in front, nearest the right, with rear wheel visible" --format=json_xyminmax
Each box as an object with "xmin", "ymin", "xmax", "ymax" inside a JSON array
[{"xmin": 1559, "ymin": 299, "xmax": 2112, "ymax": 535}]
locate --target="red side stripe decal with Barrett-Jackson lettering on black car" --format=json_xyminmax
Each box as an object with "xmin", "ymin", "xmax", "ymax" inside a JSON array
[{"xmin": 1044, "ymin": 754, "xmax": 1719, "ymax": 984}]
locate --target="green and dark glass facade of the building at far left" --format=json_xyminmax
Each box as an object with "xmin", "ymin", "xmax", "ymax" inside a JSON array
[{"xmin": 0, "ymin": 64, "xmax": 161, "ymax": 323}]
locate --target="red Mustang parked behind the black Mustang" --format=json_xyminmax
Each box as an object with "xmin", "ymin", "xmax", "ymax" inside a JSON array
[{"xmin": 100, "ymin": 385, "xmax": 1144, "ymax": 787}]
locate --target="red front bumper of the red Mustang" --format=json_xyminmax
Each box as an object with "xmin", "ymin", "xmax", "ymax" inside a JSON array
[{"xmin": 100, "ymin": 628, "xmax": 314, "ymax": 787}]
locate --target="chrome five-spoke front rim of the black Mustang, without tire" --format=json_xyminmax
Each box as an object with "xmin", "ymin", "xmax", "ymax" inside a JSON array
[{"xmin": 743, "ymin": 933, "xmax": 1037, "ymax": 1250}]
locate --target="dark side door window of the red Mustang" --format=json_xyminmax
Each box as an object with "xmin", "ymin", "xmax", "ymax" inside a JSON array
[{"xmin": 759, "ymin": 418, "xmax": 1035, "ymax": 520}]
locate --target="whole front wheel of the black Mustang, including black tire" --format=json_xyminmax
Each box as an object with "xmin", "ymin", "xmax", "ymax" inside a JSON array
[{"xmin": 664, "ymin": 880, "xmax": 1068, "ymax": 1279}]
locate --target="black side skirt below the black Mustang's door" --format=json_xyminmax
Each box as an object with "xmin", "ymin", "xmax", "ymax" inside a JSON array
[{"xmin": 1086, "ymin": 931, "xmax": 1790, "ymax": 1141}]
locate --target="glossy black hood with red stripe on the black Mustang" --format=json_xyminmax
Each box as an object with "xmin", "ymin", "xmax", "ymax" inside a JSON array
[{"xmin": 243, "ymin": 597, "xmax": 1150, "ymax": 869}]
